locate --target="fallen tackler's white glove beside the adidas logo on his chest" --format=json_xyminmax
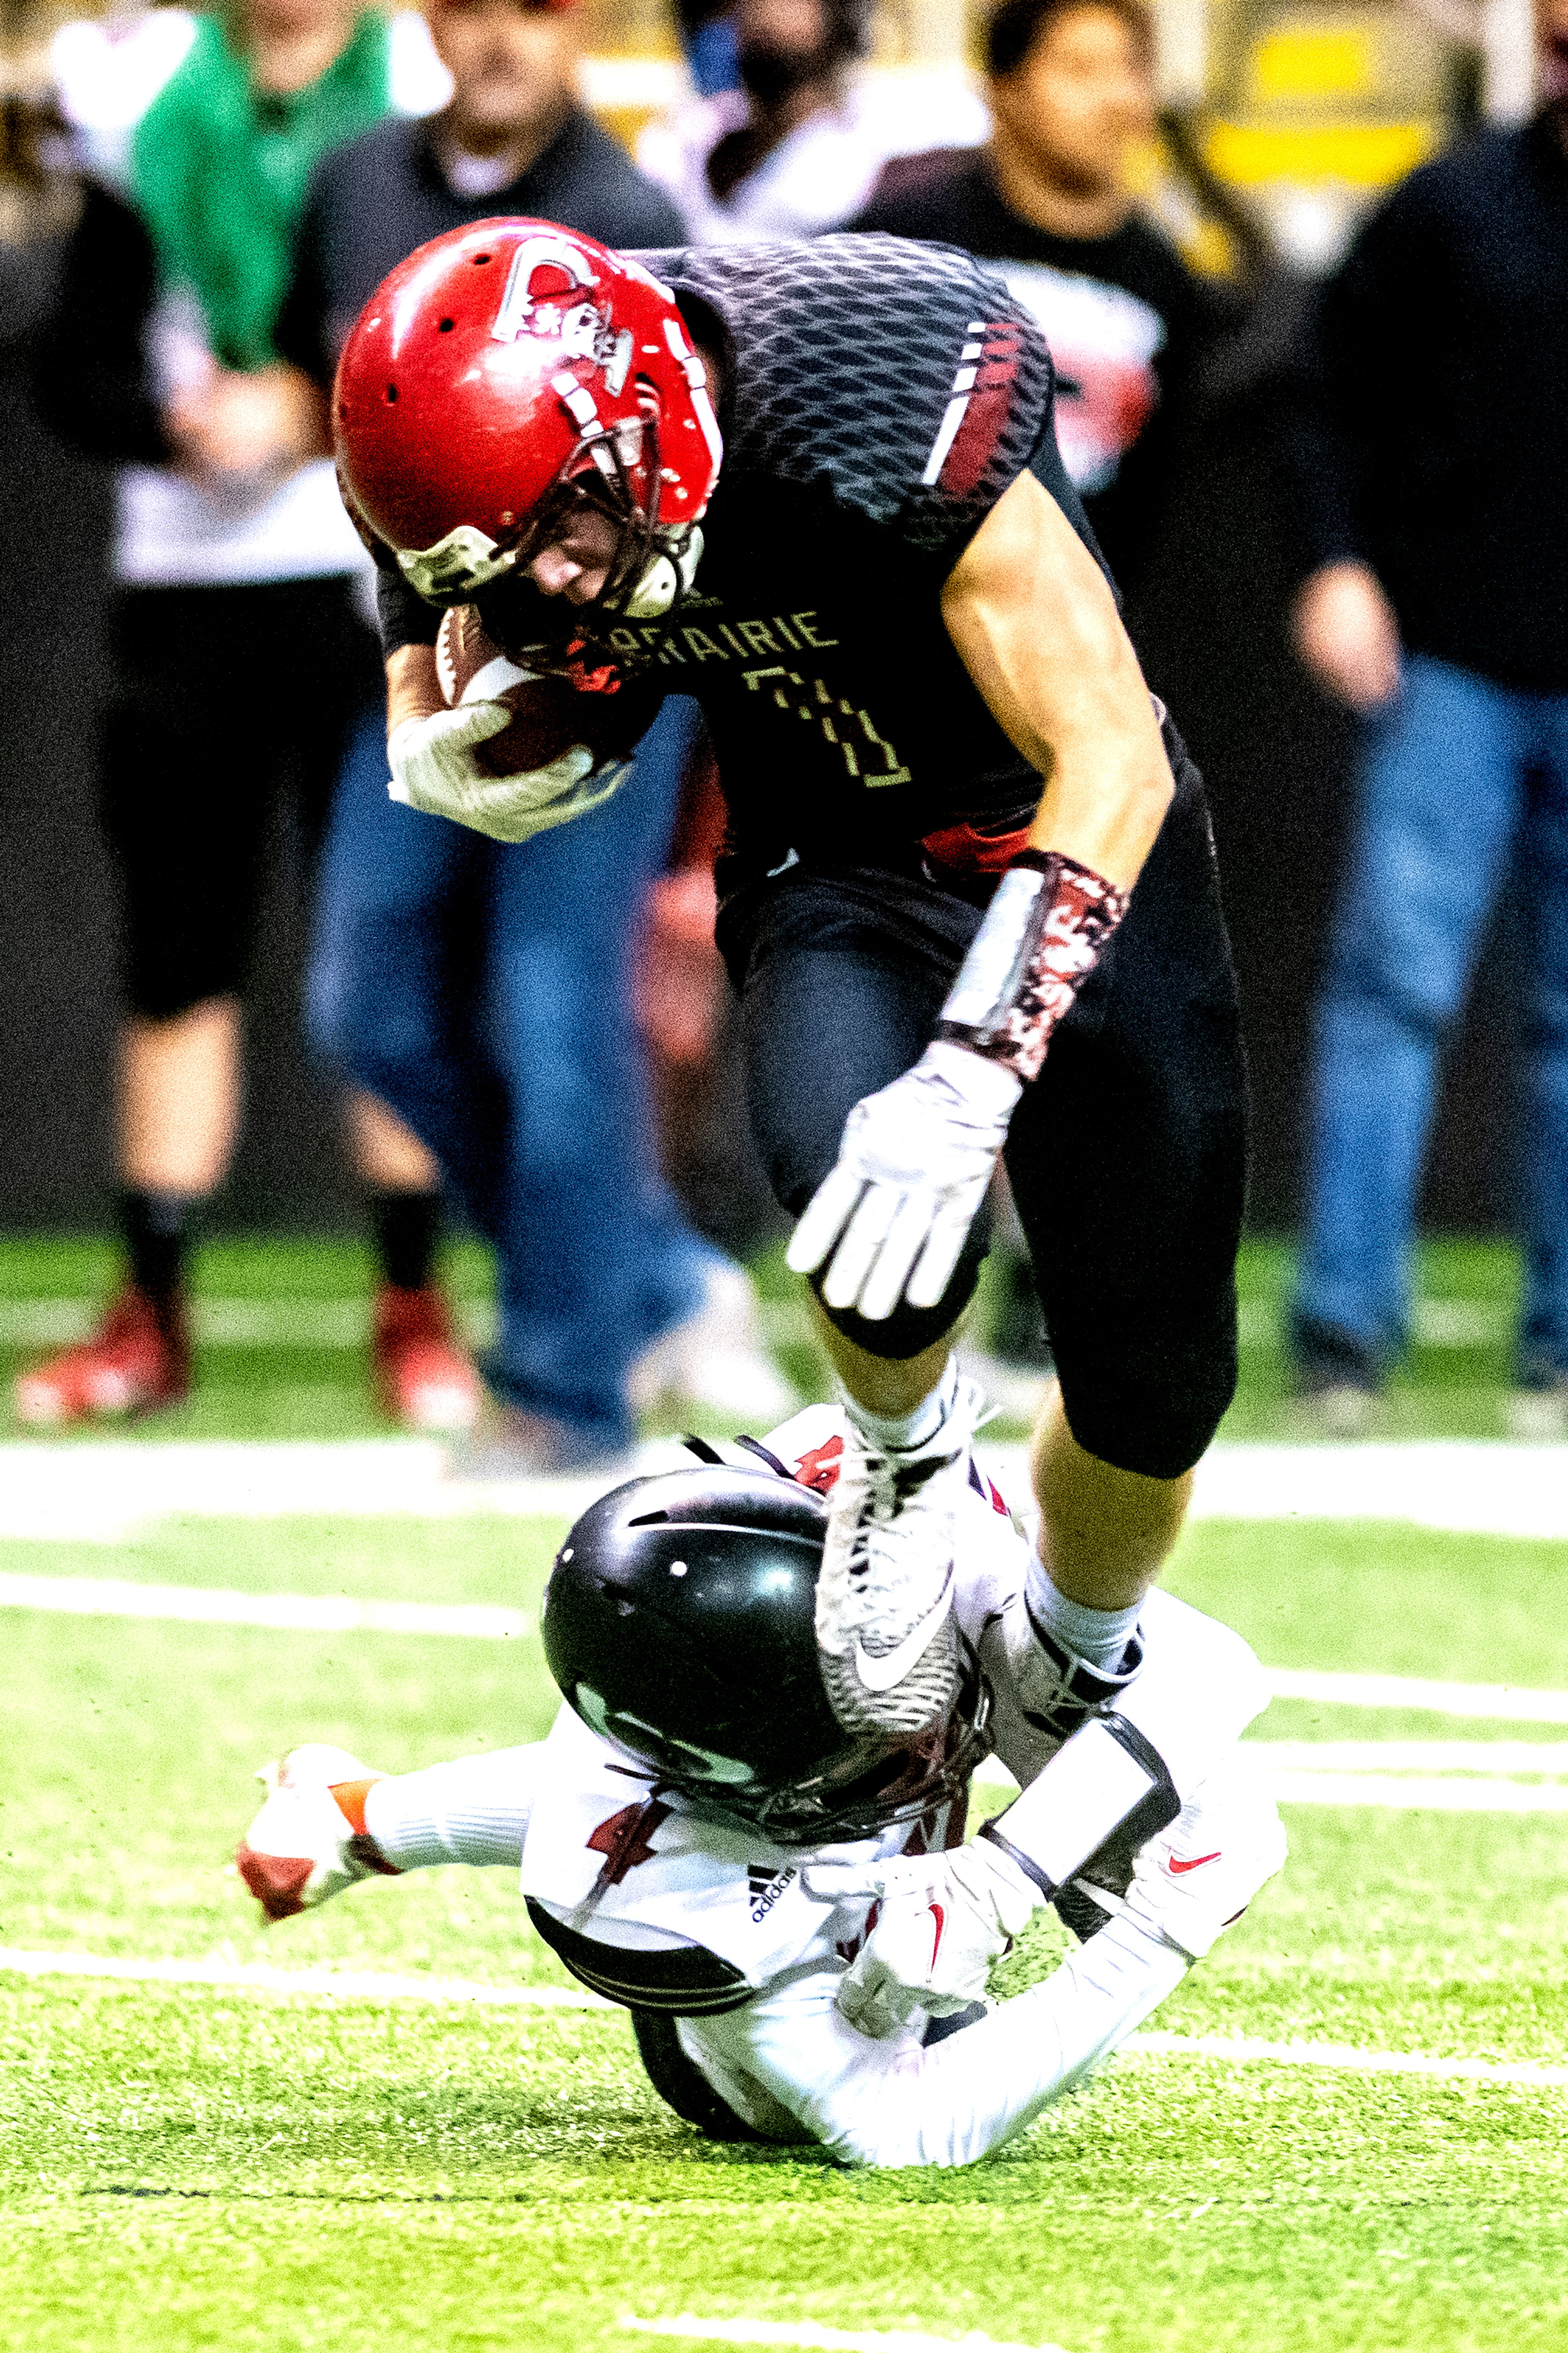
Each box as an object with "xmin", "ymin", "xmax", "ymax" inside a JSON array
[{"xmin": 805, "ymin": 1843, "xmax": 1040, "ymax": 2042}]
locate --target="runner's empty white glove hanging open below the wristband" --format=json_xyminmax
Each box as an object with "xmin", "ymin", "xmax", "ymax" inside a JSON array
[{"xmin": 789, "ymin": 1038, "xmax": 1024, "ymax": 1322}]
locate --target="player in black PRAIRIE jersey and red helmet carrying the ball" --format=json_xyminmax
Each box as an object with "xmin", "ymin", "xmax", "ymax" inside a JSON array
[{"xmin": 334, "ymin": 221, "xmax": 1245, "ymax": 1769}]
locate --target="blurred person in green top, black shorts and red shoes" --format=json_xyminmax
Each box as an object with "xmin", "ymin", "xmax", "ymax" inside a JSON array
[{"xmin": 16, "ymin": 0, "xmax": 476, "ymax": 1424}]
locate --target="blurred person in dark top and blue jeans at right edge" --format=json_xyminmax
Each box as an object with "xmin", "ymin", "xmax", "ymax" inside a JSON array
[{"xmin": 1292, "ymin": 0, "xmax": 1568, "ymax": 1409}]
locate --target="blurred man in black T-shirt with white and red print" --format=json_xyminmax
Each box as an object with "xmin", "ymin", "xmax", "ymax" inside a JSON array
[{"xmin": 848, "ymin": 0, "xmax": 1222, "ymax": 593}]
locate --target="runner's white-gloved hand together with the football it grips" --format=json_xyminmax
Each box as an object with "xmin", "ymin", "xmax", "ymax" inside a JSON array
[{"xmin": 386, "ymin": 605, "xmax": 631, "ymax": 842}]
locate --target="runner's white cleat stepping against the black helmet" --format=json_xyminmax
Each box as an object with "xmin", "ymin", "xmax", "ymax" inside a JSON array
[{"xmin": 817, "ymin": 1379, "xmax": 984, "ymax": 1734}]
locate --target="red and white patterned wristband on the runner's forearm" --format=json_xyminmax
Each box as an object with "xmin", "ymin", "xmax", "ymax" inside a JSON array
[{"xmin": 937, "ymin": 849, "xmax": 1130, "ymax": 1080}]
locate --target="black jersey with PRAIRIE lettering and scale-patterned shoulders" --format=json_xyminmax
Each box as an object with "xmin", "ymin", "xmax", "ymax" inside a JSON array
[{"xmin": 384, "ymin": 235, "xmax": 1097, "ymax": 856}]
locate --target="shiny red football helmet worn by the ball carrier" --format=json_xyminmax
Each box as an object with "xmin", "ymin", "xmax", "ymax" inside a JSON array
[{"xmin": 332, "ymin": 221, "xmax": 723, "ymax": 619}]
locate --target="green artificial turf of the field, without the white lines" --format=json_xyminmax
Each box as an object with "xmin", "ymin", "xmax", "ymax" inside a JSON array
[{"xmin": 0, "ymin": 1242, "xmax": 1568, "ymax": 2353}]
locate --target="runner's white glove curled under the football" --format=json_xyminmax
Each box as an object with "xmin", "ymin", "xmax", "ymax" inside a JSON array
[{"xmin": 386, "ymin": 704, "xmax": 631, "ymax": 842}]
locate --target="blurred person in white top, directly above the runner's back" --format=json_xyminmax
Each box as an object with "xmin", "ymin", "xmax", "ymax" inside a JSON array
[{"xmin": 638, "ymin": 0, "xmax": 984, "ymax": 245}]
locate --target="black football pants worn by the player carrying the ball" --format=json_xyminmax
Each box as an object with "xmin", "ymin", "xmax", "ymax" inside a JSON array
[{"xmin": 718, "ymin": 727, "xmax": 1245, "ymax": 1478}]
